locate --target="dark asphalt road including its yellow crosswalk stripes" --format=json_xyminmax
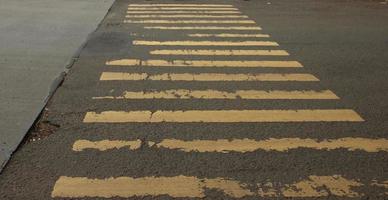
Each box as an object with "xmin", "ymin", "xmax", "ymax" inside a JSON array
[{"xmin": 0, "ymin": 0, "xmax": 388, "ymax": 199}]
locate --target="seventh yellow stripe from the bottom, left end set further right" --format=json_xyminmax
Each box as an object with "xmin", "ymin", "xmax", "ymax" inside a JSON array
[{"xmin": 150, "ymin": 49, "xmax": 289, "ymax": 56}]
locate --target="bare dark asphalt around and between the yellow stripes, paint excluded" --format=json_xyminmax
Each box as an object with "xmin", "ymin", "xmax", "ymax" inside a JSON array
[{"xmin": 0, "ymin": 0, "xmax": 388, "ymax": 200}]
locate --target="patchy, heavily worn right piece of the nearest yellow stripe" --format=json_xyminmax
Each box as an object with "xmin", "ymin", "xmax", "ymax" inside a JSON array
[{"xmin": 282, "ymin": 175, "xmax": 364, "ymax": 197}]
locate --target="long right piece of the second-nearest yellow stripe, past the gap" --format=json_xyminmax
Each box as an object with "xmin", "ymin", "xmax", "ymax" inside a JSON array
[{"xmin": 156, "ymin": 137, "xmax": 388, "ymax": 153}]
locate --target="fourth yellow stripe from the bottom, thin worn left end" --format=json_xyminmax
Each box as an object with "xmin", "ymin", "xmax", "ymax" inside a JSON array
[{"xmin": 93, "ymin": 89, "xmax": 339, "ymax": 99}]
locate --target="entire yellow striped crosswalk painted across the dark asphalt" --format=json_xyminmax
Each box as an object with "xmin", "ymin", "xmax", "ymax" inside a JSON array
[{"xmin": 51, "ymin": 3, "xmax": 388, "ymax": 198}]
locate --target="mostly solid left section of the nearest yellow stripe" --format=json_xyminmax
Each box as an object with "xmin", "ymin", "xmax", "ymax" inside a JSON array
[{"xmin": 51, "ymin": 175, "xmax": 254, "ymax": 198}]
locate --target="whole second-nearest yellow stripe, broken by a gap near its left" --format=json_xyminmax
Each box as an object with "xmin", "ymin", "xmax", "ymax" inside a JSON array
[{"xmin": 73, "ymin": 137, "xmax": 388, "ymax": 153}]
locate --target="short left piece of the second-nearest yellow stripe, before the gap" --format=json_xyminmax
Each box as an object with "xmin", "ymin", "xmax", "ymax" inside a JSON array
[{"xmin": 73, "ymin": 140, "xmax": 141, "ymax": 151}]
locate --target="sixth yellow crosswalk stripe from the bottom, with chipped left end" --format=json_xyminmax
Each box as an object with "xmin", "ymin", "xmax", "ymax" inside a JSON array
[{"xmin": 106, "ymin": 59, "xmax": 303, "ymax": 68}]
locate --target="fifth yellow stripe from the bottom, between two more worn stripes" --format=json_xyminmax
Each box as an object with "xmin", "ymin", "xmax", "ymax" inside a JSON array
[{"xmin": 100, "ymin": 72, "xmax": 319, "ymax": 81}]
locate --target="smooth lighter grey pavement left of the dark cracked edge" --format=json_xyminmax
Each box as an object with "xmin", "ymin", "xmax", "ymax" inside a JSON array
[{"xmin": 0, "ymin": 0, "xmax": 113, "ymax": 170}]
